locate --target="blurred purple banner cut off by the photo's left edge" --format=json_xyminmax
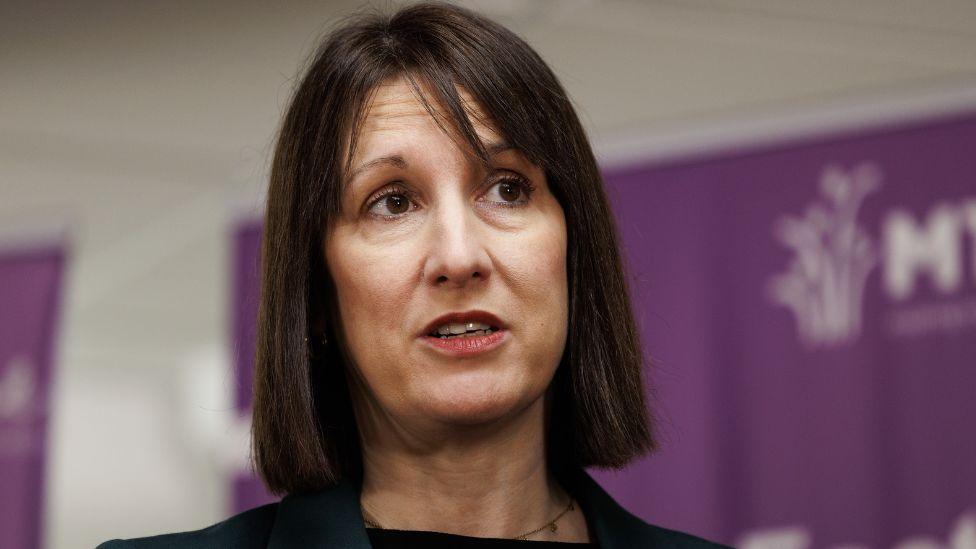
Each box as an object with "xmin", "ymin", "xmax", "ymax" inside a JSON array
[{"xmin": 0, "ymin": 246, "xmax": 64, "ymax": 549}]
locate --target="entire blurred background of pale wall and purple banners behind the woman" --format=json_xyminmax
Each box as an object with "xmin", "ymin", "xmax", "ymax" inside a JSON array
[{"xmin": 0, "ymin": 0, "xmax": 976, "ymax": 549}]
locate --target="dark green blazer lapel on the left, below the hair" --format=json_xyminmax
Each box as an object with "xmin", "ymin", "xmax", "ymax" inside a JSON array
[{"xmin": 268, "ymin": 481, "xmax": 370, "ymax": 549}]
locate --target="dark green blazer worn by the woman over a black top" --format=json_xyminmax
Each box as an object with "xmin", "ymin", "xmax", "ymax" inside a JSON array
[{"xmin": 97, "ymin": 471, "xmax": 724, "ymax": 549}]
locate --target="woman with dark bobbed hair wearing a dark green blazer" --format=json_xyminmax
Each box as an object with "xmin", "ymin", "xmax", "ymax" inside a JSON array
[{"xmin": 104, "ymin": 4, "xmax": 724, "ymax": 548}]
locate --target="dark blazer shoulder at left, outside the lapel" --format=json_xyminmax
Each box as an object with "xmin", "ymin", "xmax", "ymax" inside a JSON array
[{"xmin": 96, "ymin": 503, "xmax": 278, "ymax": 549}]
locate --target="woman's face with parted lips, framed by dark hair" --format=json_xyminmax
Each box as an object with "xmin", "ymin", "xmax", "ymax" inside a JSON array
[{"xmin": 324, "ymin": 80, "xmax": 568, "ymax": 426}]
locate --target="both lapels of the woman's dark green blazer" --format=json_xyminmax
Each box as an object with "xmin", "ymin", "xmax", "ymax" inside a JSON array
[{"xmin": 268, "ymin": 469, "xmax": 648, "ymax": 549}]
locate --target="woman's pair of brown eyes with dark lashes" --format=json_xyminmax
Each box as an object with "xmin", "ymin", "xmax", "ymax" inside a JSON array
[{"xmin": 365, "ymin": 173, "xmax": 536, "ymax": 221}]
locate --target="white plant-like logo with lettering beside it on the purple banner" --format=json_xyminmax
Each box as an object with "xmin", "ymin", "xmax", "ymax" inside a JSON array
[{"xmin": 767, "ymin": 162, "xmax": 976, "ymax": 348}]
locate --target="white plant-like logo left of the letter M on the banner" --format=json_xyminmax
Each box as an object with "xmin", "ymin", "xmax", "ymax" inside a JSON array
[{"xmin": 768, "ymin": 163, "xmax": 881, "ymax": 347}]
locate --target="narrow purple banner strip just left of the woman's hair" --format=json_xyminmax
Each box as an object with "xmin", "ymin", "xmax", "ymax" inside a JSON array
[{"xmin": 231, "ymin": 221, "xmax": 277, "ymax": 513}]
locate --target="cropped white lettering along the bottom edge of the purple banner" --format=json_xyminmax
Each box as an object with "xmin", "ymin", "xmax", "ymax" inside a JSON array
[{"xmin": 735, "ymin": 511, "xmax": 976, "ymax": 549}]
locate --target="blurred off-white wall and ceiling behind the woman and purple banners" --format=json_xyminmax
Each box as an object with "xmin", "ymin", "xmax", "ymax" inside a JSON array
[{"xmin": 0, "ymin": 0, "xmax": 976, "ymax": 548}]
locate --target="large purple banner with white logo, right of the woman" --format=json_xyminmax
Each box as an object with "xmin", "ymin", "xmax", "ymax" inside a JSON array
[{"xmin": 600, "ymin": 113, "xmax": 976, "ymax": 549}]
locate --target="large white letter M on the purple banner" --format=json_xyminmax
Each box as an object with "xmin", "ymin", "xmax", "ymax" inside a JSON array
[{"xmin": 884, "ymin": 204, "xmax": 964, "ymax": 300}]
